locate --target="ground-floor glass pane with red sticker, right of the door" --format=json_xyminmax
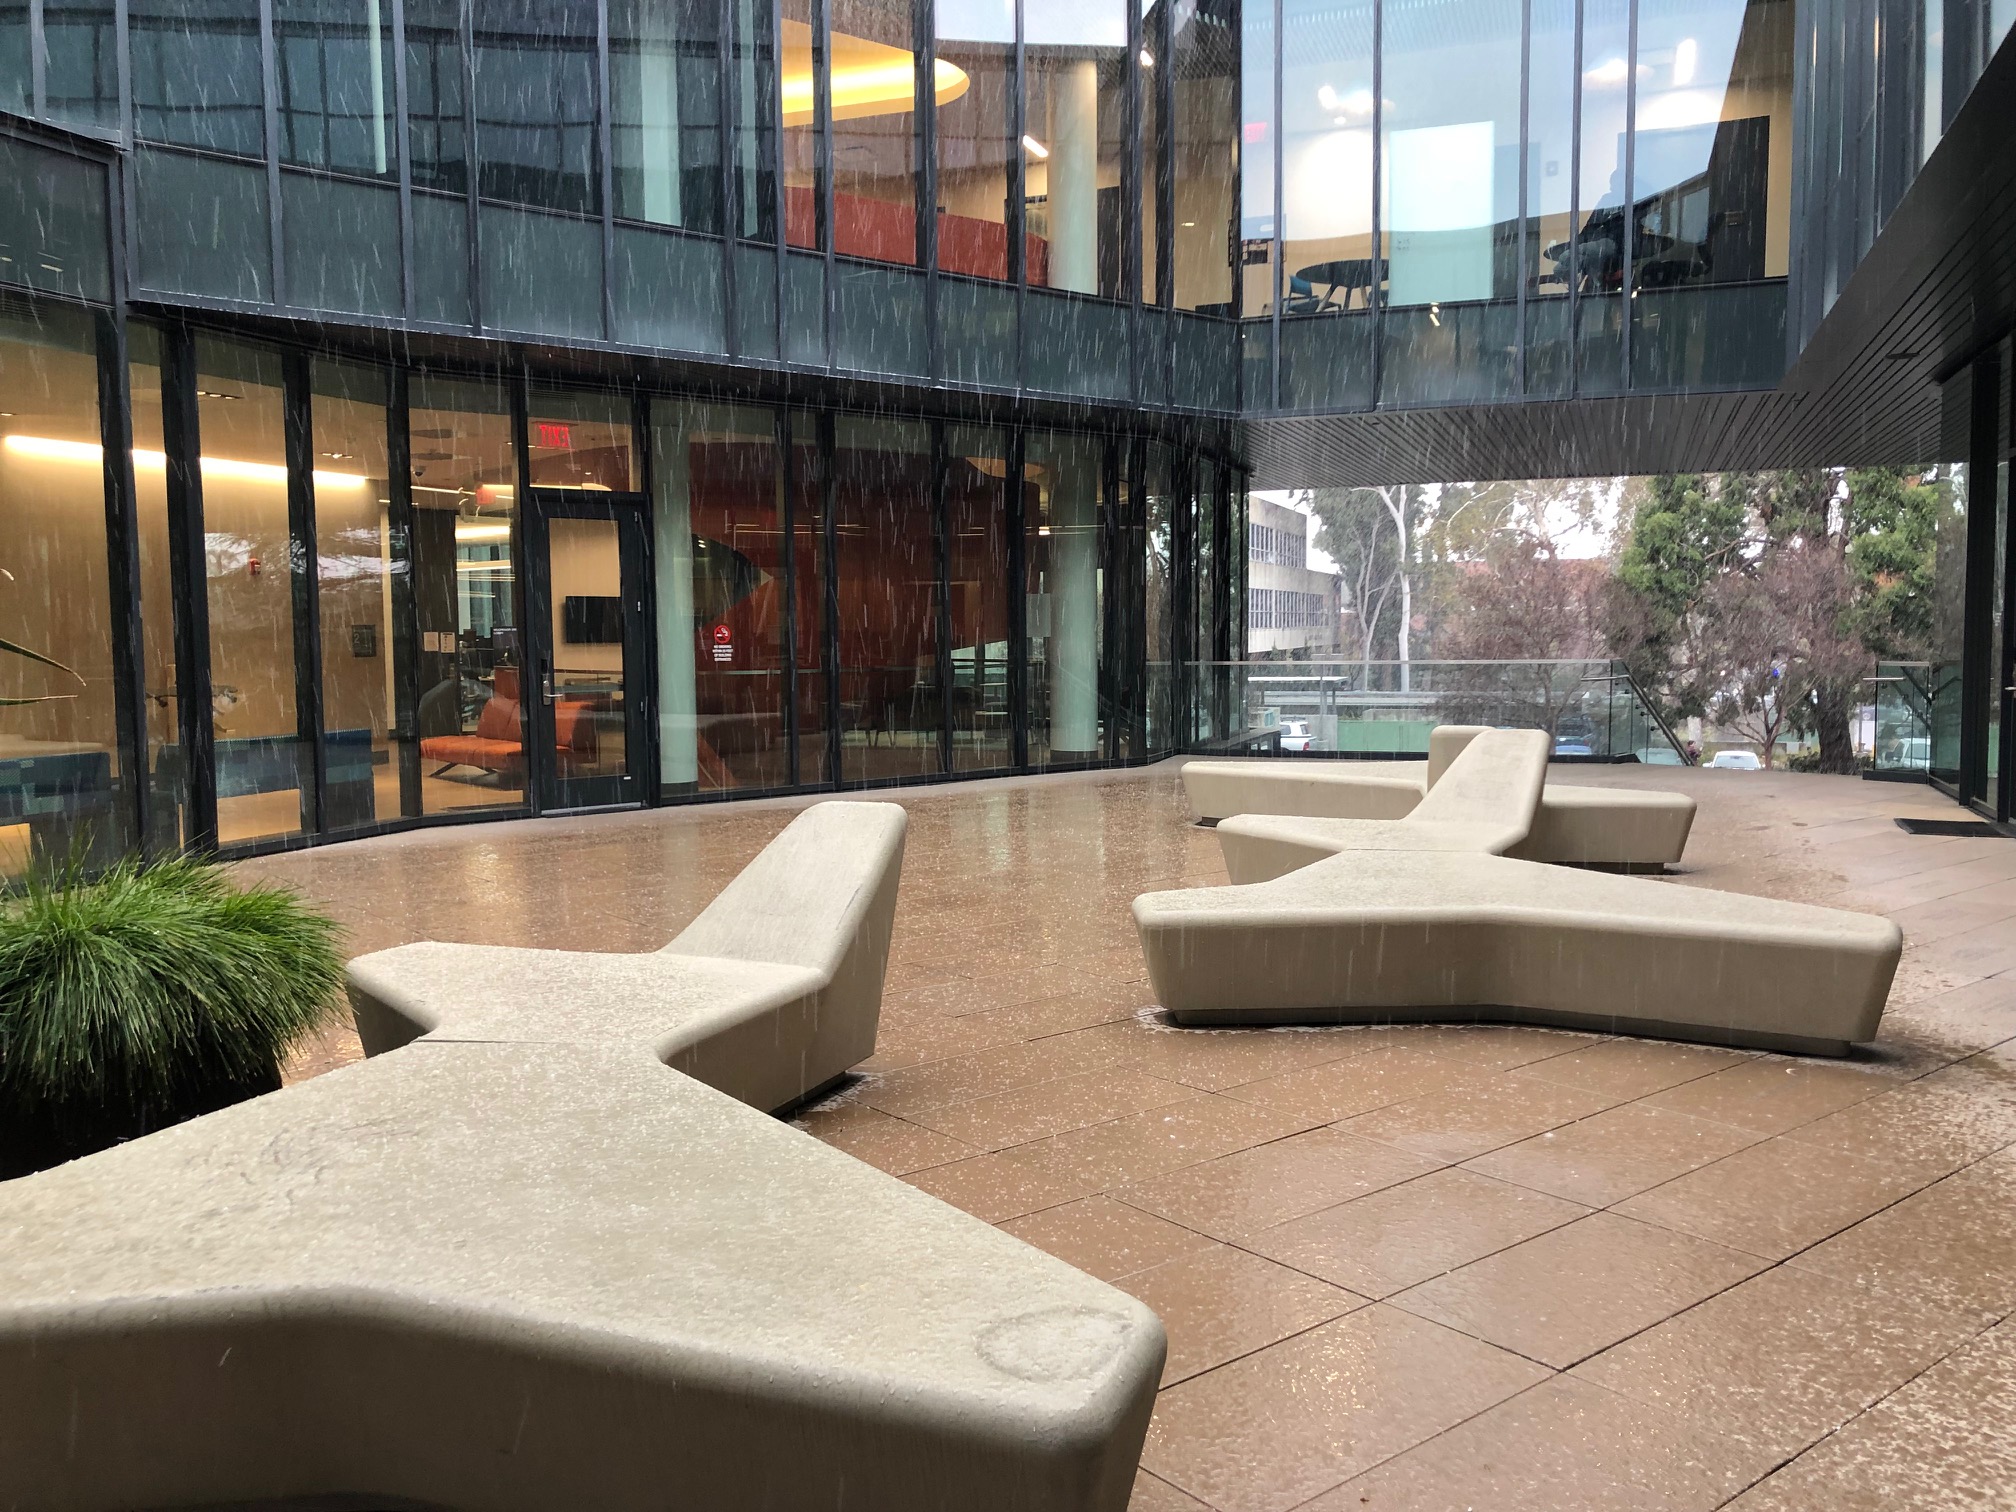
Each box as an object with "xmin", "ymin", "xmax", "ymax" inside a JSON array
[{"xmin": 651, "ymin": 399, "xmax": 790, "ymax": 806}]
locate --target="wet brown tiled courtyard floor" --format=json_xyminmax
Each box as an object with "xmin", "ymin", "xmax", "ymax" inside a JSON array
[{"xmin": 248, "ymin": 766, "xmax": 2016, "ymax": 1512}]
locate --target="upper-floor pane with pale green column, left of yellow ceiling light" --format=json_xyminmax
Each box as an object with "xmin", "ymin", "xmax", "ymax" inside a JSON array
[{"xmin": 609, "ymin": 0, "xmax": 722, "ymax": 236}]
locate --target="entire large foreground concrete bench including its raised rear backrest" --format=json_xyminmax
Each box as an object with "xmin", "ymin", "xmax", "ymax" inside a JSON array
[{"xmin": 0, "ymin": 802, "xmax": 1165, "ymax": 1512}]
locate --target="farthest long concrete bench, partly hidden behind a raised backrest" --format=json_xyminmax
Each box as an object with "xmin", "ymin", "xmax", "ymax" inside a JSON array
[{"xmin": 1183, "ymin": 726, "xmax": 1693, "ymax": 871}]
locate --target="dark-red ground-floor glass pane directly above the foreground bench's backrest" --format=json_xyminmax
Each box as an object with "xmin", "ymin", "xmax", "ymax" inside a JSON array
[{"xmin": 833, "ymin": 415, "xmax": 943, "ymax": 782}]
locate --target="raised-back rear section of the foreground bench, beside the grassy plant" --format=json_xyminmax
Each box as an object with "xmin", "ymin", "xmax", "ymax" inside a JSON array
[{"xmin": 349, "ymin": 802, "xmax": 905, "ymax": 1111}]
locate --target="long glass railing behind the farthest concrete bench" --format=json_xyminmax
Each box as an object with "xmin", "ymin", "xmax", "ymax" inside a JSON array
[{"xmin": 1191, "ymin": 659, "xmax": 1687, "ymax": 766}]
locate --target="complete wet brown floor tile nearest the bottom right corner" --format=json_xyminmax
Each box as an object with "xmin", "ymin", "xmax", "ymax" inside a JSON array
[{"xmin": 1574, "ymin": 1266, "xmax": 1974, "ymax": 1458}]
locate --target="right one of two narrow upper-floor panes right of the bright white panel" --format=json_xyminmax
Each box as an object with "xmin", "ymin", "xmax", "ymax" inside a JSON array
[{"xmin": 1574, "ymin": 0, "xmax": 1631, "ymax": 393}]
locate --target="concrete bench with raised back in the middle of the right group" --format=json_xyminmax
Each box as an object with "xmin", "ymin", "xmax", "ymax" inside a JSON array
[{"xmin": 1218, "ymin": 730, "xmax": 1546, "ymax": 883}]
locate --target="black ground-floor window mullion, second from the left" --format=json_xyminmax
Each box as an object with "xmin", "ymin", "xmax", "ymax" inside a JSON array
[{"xmin": 161, "ymin": 327, "xmax": 218, "ymax": 851}]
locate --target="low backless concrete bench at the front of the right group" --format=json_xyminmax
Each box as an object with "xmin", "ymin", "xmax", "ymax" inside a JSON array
[{"xmin": 1133, "ymin": 849, "xmax": 1903, "ymax": 1054}]
